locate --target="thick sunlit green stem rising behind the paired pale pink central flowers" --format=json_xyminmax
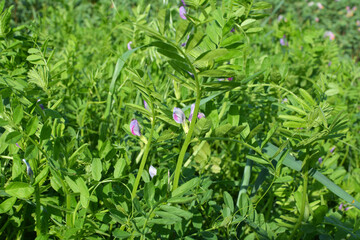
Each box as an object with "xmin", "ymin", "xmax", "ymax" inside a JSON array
[{"xmin": 173, "ymin": 88, "xmax": 201, "ymax": 191}]
